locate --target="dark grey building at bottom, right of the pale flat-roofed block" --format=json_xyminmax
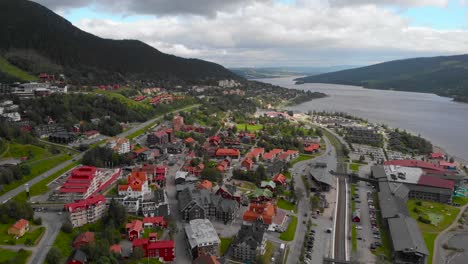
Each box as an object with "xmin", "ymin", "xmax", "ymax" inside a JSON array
[{"xmin": 232, "ymin": 221, "xmax": 266, "ymax": 263}]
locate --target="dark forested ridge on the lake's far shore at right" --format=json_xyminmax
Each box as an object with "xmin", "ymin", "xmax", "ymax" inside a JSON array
[{"xmin": 296, "ymin": 55, "xmax": 468, "ymax": 102}]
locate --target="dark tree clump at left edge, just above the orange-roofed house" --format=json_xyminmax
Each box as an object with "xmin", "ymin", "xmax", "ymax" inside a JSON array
[{"xmin": 0, "ymin": 199, "xmax": 34, "ymax": 224}]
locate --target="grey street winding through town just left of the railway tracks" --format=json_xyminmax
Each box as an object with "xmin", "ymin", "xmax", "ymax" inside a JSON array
[{"xmin": 287, "ymin": 135, "xmax": 336, "ymax": 264}]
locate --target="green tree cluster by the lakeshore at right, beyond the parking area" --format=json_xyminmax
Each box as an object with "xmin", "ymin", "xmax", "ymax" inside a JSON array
[{"xmin": 388, "ymin": 129, "xmax": 432, "ymax": 154}]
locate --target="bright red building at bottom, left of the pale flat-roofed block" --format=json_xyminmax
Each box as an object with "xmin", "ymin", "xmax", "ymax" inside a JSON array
[{"xmin": 132, "ymin": 233, "xmax": 175, "ymax": 262}]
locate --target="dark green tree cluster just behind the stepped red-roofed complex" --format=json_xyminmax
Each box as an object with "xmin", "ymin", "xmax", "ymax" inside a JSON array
[{"xmin": 82, "ymin": 147, "xmax": 135, "ymax": 167}]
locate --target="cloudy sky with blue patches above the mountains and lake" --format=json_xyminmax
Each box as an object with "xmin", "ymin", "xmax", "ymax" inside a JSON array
[{"xmin": 34, "ymin": 0, "xmax": 468, "ymax": 67}]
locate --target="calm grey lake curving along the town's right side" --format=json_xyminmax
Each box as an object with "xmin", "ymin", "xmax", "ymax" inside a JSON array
[{"xmin": 257, "ymin": 77, "xmax": 468, "ymax": 160}]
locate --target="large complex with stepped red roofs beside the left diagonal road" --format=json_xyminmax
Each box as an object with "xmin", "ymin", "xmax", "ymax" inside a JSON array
[{"xmin": 57, "ymin": 166, "xmax": 121, "ymax": 201}]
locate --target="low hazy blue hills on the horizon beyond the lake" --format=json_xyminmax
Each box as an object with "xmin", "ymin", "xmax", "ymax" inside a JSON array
[{"xmin": 230, "ymin": 65, "xmax": 359, "ymax": 79}]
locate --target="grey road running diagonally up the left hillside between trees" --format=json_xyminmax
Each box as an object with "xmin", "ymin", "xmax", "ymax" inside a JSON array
[{"xmin": 0, "ymin": 102, "xmax": 200, "ymax": 203}]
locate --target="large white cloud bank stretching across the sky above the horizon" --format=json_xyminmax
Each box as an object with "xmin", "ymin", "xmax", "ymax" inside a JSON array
[{"xmin": 71, "ymin": 1, "xmax": 468, "ymax": 66}]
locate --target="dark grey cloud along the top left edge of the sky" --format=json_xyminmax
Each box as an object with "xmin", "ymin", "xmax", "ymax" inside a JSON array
[{"xmin": 34, "ymin": 0, "xmax": 271, "ymax": 17}]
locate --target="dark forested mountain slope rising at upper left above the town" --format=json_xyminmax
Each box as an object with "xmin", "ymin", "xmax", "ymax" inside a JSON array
[{"xmin": 0, "ymin": 0, "xmax": 239, "ymax": 84}]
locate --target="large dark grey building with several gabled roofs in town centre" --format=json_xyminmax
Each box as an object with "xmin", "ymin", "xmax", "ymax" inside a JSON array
[{"xmin": 178, "ymin": 187, "xmax": 239, "ymax": 224}]
